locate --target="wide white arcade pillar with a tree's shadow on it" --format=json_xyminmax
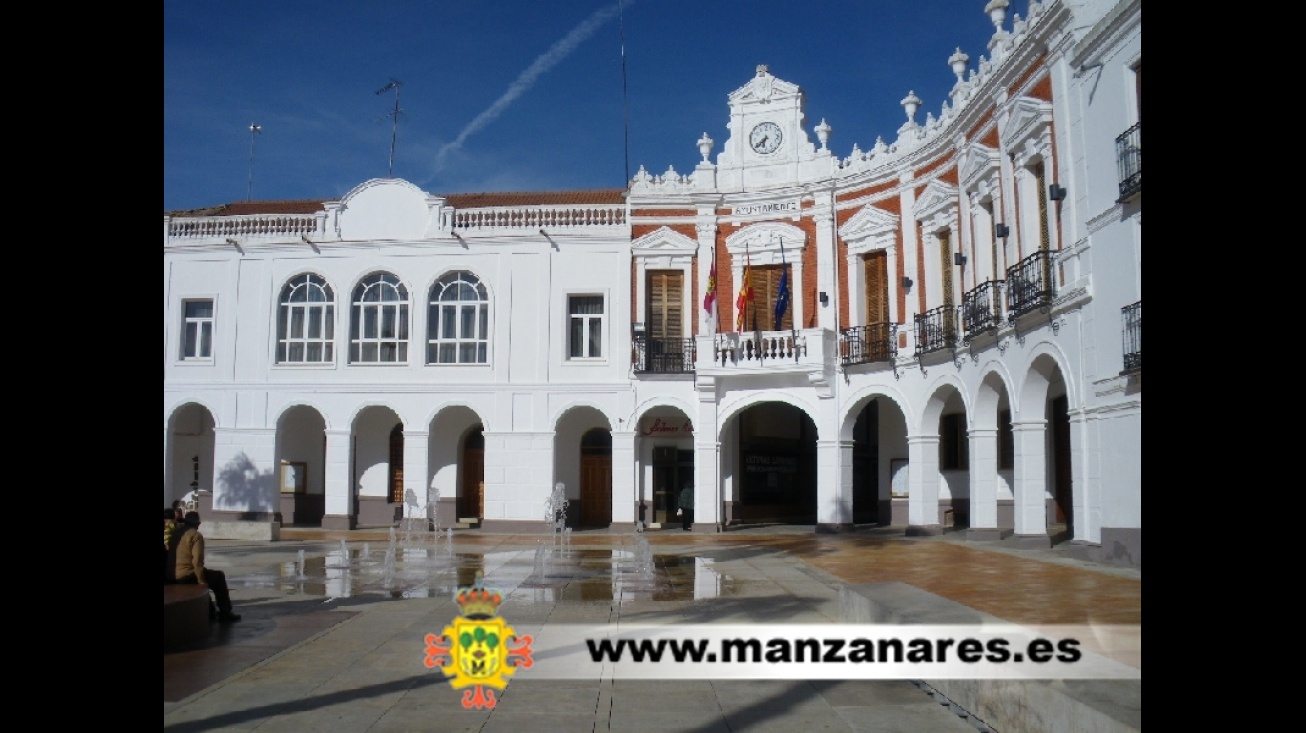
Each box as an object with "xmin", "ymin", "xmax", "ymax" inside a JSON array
[{"xmin": 210, "ymin": 427, "xmax": 281, "ymax": 519}]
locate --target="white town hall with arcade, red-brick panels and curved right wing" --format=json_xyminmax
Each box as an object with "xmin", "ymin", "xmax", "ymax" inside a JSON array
[{"xmin": 163, "ymin": 0, "xmax": 1143, "ymax": 566}]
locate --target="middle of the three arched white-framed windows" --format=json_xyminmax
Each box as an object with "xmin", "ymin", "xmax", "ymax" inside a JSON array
[{"xmin": 349, "ymin": 272, "xmax": 409, "ymax": 363}]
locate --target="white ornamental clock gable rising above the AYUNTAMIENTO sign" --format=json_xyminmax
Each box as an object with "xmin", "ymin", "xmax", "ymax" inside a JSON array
[{"xmin": 717, "ymin": 65, "xmax": 833, "ymax": 192}]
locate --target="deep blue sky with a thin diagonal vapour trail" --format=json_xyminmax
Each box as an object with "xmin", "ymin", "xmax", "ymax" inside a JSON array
[{"xmin": 163, "ymin": 0, "xmax": 1028, "ymax": 212}]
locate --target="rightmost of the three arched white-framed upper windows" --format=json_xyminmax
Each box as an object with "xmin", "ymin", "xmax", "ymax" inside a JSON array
[{"xmin": 426, "ymin": 270, "xmax": 490, "ymax": 365}]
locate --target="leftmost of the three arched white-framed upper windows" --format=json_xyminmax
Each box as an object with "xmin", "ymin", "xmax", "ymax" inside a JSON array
[{"xmin": 277, "ymin": 273, "xmax": 336, "ymax": 365}]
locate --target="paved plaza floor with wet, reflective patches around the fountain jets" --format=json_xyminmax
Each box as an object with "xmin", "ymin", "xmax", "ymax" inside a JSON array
[{"xmin": 163, "ymin": 527, "xmax": 1141, "ymax": 733}]
